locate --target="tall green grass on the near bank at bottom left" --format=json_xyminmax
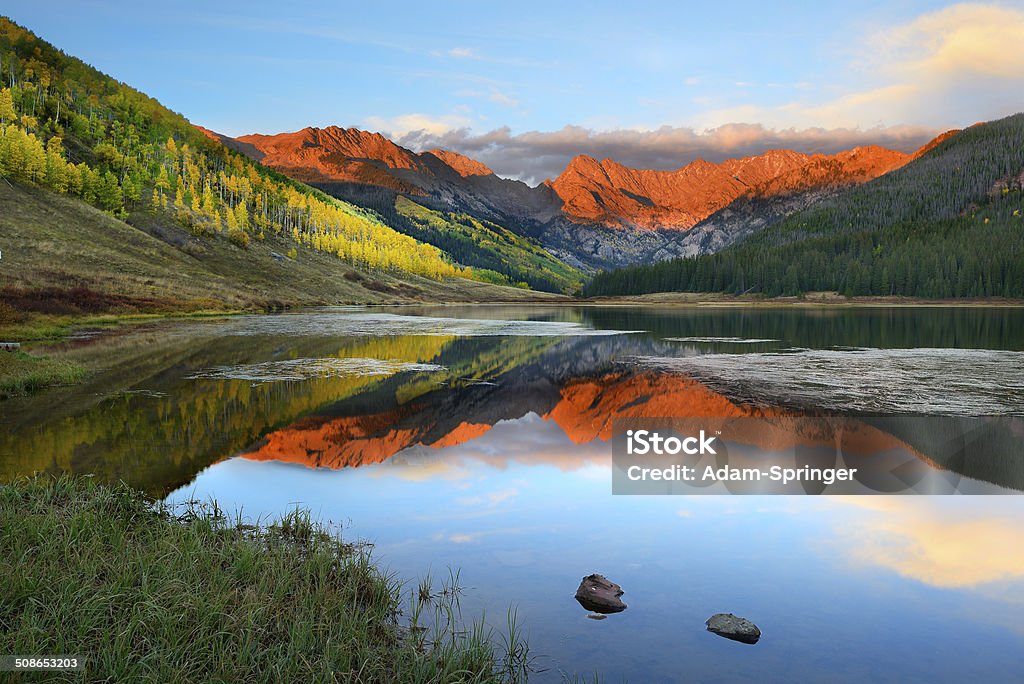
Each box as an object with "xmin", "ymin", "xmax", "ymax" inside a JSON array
[{"xmin": 0, "ymin": 476, "xmax": 525, "ymax": 682}]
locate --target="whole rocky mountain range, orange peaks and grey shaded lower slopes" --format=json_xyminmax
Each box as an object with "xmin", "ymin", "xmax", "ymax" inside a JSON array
[{"xmin": 209, "ymin": 126, "xmax": 955, "ymax": 270}]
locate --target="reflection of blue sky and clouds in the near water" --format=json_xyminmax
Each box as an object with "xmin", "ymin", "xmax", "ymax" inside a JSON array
[{"xmin": 172, "ymin": 415, "xmax": 1024, "ymax": 682}]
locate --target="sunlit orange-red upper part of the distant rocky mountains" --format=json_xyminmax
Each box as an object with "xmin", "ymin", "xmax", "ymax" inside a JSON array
[{"xmin": 228, "ymin": 126, "xmax": 911, "ymax": 235}]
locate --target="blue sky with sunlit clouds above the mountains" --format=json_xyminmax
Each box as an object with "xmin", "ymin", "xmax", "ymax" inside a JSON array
[{"xmin": 4, "ymin": 0, "xmax": 1024, "ymax": 178}]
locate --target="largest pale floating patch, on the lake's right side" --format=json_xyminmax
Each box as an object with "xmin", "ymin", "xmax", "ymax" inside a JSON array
[{"xmin": 637, "ymin": 348, "xmax": 1024, "ymax": 416}]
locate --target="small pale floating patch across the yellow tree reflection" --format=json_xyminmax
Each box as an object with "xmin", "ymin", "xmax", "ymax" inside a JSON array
[{"xmin": 187, "ymin": 358, "xmax": 444, "ymax": 382}]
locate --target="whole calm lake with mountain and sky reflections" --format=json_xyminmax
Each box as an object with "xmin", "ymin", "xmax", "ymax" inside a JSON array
[{"xmin": 0, "ymin": 306, "xmax": 1024, "ymax": 682}]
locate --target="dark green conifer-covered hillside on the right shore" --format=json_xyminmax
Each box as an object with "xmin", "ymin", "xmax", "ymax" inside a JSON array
[{"xmin": 587, "ymin": 115, "xmax": 1024, "ymax": 298}]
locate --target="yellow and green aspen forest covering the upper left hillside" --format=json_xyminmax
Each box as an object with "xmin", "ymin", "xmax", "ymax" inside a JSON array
[{"xmin": 0, "ymin": 17, "xmax": 528, "ymax": 309}]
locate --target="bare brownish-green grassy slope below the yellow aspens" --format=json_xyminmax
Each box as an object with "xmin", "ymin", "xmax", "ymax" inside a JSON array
[{"xmin": 0, "ymin": 181, "xmax": 557, "ymax": 321}]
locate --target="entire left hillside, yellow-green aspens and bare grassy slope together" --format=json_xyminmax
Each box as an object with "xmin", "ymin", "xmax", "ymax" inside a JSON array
[{"xmin": 0, "ymin": 17, "xmax": 536, "ymax": 304}]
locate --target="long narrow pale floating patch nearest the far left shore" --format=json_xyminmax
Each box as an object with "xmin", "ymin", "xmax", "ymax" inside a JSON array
[{"xmin": 209, "ymin": 311, "xmax": 639, "ymax": 337}]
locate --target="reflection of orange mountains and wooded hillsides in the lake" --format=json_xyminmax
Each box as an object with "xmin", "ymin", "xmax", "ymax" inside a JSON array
[{"xmin": 0, "ymin": 307, "xmax": 1024, "ymax": 495}]
